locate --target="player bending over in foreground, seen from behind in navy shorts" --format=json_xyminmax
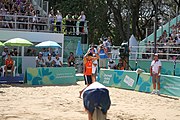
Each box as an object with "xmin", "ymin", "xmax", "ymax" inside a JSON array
[{"xmin": 81, "ymin": 82, "xmax": 111, "ymax": 120}]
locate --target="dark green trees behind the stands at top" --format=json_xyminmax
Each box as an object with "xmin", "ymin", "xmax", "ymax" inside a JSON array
[{"xmin": 49, "ymin": 0, "xmax": 180, "ymax": 45}]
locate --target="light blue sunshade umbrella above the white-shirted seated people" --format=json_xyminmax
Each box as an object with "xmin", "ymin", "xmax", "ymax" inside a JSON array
[{"xmin": 35, "ymin": 41, "xmax": 62, "ymax": 48}]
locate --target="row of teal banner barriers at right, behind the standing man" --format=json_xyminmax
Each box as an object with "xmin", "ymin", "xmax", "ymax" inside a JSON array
[{"xmin": 98, "ymin": 69, "xmax": 180, "ymax": 97}]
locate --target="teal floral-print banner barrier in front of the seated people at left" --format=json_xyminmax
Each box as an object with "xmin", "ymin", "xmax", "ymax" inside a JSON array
[{"xmin": 25, "ymin": 67, "xmax": 76, "ymax": 85}]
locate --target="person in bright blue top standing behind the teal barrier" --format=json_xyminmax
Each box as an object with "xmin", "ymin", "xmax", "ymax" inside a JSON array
[{"xmin": 98, "ymin": 45, "xmax": 108, "ymax": 68}]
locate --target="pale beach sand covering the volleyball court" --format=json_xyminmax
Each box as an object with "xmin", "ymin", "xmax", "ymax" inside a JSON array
[{"xmin": 0, "ymin": 81, "xmax": 180, "ymax": 120}]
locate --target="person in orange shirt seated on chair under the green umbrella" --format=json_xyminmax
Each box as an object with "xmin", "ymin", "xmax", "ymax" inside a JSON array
[{"xmin": 4, "ymin": 53, "xmax": 14, "ymax": 76}]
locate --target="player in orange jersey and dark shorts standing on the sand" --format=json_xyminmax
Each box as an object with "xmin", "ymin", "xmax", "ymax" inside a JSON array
[{"xmin": 79, "ymin": 52, "xmax": 99, "ymax": 97}]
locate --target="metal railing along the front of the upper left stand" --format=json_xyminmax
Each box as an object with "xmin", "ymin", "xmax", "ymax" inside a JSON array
[{"xmin": 0, "ymin": 14, "xmax": 88, "ymax": 35}]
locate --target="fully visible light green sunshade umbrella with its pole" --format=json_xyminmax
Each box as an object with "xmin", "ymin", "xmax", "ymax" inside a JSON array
[{"xmin": 4, "ymin": 38, "xmax": 33, "ymax": 75}]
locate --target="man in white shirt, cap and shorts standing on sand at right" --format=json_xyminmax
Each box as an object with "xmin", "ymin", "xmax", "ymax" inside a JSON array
[{"xmin": 150, "ymin": 53, "xmax": 162, "ymax": 95}]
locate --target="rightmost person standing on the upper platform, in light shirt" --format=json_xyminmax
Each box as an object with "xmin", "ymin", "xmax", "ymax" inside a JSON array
[{"xmin": 78, "ymin": 11, "xmax": 86, "ymax": 34}]
